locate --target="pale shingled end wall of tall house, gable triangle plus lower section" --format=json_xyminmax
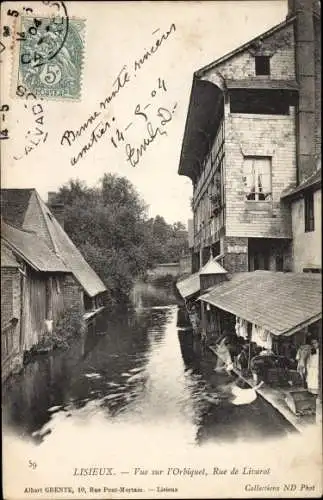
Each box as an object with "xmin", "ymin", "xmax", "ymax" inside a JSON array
[{"xmin": 204, "ymin": 23, "xmax": 297, "ymax": 240}]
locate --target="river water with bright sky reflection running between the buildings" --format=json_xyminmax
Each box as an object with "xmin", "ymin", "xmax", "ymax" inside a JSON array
[{"xmin": 3, "ymin": 284, "xmax": 291, "ymax": 447}]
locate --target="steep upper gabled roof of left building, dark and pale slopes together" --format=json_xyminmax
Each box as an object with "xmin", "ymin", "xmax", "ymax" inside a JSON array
[{"xmin": 1, "ymin": 189, "xmax": 106, "ymax": 297}]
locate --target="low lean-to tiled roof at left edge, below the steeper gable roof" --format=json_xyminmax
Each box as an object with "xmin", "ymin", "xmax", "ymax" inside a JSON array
[{"xmin": 1, "ymin": 222, "xmax": 70, "ymax": 273}]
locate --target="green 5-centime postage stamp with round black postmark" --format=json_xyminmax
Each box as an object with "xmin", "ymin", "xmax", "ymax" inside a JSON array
[{"xmin": 14, "ymin": 17, "xmax": 85, "ymax": 100}]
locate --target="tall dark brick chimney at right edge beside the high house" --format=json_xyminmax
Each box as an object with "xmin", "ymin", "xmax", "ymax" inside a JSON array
[{"xmin": 288, "ymin": 0, "xmax": 321, "ymax": 183}]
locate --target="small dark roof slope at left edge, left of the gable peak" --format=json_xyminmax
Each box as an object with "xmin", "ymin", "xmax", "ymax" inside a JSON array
[{"xmin": 1, "ymin": 189, "xmax": 34, "ymax": 227}]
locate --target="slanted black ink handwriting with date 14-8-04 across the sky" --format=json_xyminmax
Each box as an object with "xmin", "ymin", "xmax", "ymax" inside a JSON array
[{"xmin": 60, "ymin": 23, "xmax": 177, "ymax": 167}]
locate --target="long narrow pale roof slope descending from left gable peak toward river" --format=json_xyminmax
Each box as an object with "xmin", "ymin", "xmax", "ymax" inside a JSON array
[{"xmin": 37, "ymin": 194, "xmax": 106, "ymax": 297}]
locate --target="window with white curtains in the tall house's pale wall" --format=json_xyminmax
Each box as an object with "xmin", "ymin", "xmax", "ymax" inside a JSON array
[{"xmin": 243, "ymin": 157, "xmax": 271, "ymax": 201}]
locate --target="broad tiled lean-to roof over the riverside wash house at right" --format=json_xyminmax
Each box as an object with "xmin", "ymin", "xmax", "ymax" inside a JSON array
[{"xmin": 200, "ymin": 271, "xmax": 322, "ymax": 335}]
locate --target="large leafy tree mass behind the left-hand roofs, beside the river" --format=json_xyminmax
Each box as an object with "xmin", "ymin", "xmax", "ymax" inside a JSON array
[{"xmin": 57, "ymin": 174, "xmax": 188, "ymax": 306}]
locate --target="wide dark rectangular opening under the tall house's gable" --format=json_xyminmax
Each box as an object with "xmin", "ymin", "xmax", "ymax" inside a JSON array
[{"xmin": 230, "ymin": 89, "xmax": 297, "ymax": 115}]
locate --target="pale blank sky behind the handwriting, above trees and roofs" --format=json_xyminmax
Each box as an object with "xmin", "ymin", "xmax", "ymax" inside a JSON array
[{"xmin": 1, "ymin": 0, "xmax": 287, "ymax": 223}]
